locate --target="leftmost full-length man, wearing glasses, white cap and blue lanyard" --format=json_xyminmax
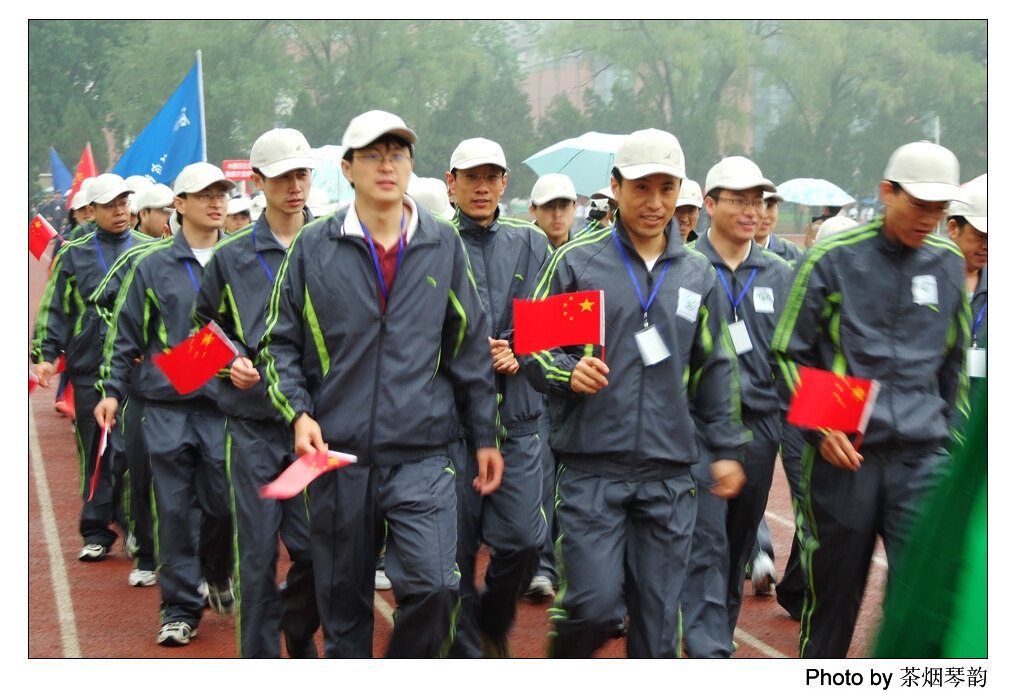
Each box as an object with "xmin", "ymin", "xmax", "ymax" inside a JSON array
[{"xmin": 33, "ymin": 173, "xmax": 148, "ymax": 561}]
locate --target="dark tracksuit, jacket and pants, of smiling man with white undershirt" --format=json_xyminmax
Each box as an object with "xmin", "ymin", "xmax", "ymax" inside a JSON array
[{"xmin": 96, "ymin": 231, "xmax": 233, "ymax": 627}]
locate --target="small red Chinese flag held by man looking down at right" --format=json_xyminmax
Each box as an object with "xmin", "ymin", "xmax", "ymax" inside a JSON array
[{"xmin": 786, "ymin": 367, "xmax": 880, "ymax": 434}]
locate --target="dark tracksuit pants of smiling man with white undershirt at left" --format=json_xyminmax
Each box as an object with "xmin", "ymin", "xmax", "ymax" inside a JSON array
[{"xmin": 141, "ymin": 401, "xmax": 233, "ymax": 628}]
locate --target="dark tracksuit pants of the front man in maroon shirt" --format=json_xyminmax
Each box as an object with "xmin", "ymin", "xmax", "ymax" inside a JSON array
[{"xmin": 307, "ymin": 453, "xmax": 458, "ymax": 657}]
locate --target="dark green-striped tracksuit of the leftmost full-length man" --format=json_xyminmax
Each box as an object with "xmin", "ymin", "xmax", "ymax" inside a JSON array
[{"xmin": 33, "ymin": 222, "xmax": 149, "ymax": 547}]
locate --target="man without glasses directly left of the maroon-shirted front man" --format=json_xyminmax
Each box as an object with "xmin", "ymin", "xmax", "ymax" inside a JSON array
[{"xmin": 194, "ymin": 129, "xmax": 318, "ymax": 657}]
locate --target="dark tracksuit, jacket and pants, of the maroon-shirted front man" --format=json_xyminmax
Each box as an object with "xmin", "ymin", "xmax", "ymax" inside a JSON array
[{"xmin": 258, "ymin": 197, "xmax": 497, "ymax": 656}]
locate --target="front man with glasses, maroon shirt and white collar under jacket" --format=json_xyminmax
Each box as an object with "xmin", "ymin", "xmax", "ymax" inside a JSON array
[{"xmin": 257, "ymin": 111, "xmax": 504, "ymax": 657}]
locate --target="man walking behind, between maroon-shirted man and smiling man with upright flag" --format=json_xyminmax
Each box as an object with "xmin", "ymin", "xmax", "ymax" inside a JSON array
[{"xmin": 446, "ymin": 138, "xmax": 550, "ymax": 657}]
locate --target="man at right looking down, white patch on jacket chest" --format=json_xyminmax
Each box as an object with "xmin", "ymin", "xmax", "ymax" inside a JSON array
[{"xmin": 772, "ymin": 141, "xmax": 970, "ymax": 657}]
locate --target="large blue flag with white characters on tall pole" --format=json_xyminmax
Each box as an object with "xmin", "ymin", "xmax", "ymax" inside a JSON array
[{"xmin": 113, "ymin": 55, "xmax": 205, "ymax": 185}]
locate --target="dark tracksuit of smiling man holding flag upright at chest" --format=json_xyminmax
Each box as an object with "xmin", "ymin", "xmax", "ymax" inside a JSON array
[{"xmin": 522, "ymin": 219, "xmax": 751, "ymax": 657}]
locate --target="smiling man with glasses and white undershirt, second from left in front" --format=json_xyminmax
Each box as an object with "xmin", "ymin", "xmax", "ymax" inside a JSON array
[{"xmin": 94, "ymin": 163, "xmax": 234, "ymax": 645}]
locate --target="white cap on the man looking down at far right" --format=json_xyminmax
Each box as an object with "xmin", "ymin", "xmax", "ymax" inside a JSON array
[{"xmin": 882, "ymin": 140, "xmax": 963, "ymax": 201}]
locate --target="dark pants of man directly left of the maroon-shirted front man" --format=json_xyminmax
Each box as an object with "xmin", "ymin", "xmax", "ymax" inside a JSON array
[{"xmin": 226, "ymin": 418, "xmax": 320, "ymax": 657}]
